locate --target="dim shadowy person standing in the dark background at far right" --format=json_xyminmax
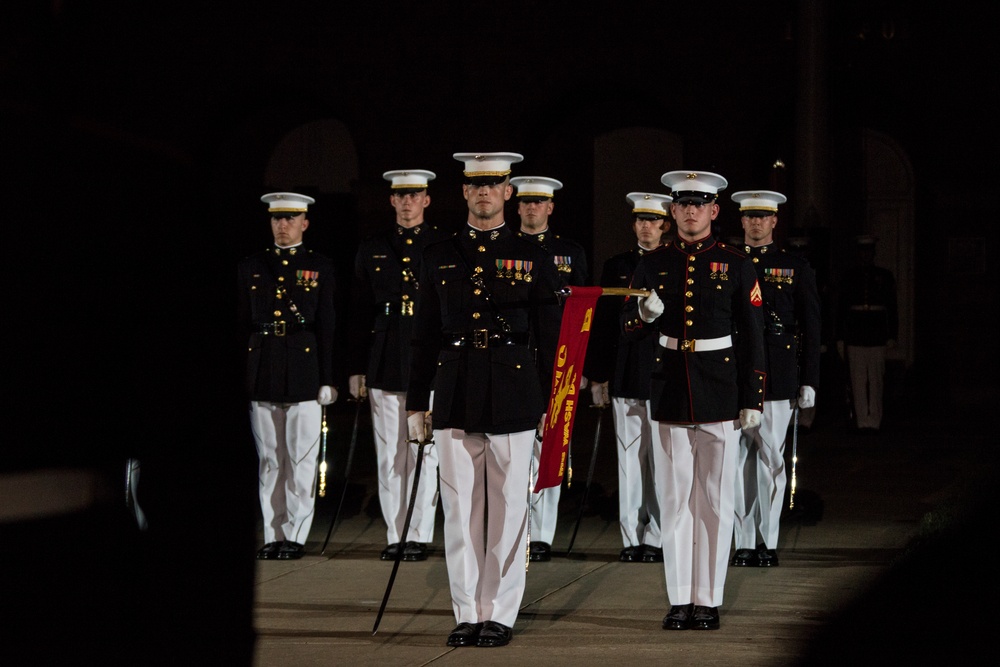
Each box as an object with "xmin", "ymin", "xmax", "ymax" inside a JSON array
[{"xmin": 837, "ymin": 235, "xmax": 899, "ymax": 433}]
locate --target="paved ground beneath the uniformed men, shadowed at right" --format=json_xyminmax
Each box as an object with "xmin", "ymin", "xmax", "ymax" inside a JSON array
[{"xmin": 253, "ymin": 396, "xmax": 998, "ymax": 667}]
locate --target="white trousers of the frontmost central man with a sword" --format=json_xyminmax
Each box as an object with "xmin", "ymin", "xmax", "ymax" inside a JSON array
[{"xmin": 434, "ymin": 429, "xmax": 535, "ymax": 627}]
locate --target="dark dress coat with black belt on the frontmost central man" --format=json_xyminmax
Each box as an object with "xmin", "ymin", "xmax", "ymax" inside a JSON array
[{"xmin": 406, "ymin": 225, "xmax": 562, "ymax": 433}]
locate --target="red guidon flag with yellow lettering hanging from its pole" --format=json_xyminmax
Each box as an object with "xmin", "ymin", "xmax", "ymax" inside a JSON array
[{"xmin": 534, "ymin": 287, "xmax": 605, "ymax": 493}]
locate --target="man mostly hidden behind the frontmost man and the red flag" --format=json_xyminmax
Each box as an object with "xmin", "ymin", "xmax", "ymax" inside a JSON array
[{"xmin": 510, "ymin": 176, "xmax": 587, "ymax": 561}]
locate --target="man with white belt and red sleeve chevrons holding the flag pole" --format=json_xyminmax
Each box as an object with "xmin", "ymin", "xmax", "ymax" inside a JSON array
[{"xmin": 622, "ymin": 171, "xmax": 765, "ymax": 630}]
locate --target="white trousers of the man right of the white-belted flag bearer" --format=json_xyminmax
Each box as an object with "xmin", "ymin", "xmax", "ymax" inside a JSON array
[{"xmin": 734, "ymin": 399, "xmax": 795, "ymax": 549}]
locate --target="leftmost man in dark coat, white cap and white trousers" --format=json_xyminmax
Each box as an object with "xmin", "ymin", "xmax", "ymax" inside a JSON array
[{"xmin": 238, "ymin": 192, "xmax": 337, "ymax": 560}]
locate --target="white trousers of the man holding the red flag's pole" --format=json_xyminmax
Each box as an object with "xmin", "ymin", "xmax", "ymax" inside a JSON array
[{"xmin": 653, "ymin": 421, "xmax": 740, "ymax": 607}]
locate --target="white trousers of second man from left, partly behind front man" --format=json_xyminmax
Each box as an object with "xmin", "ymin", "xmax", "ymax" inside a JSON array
[{"xmin": 368, "ymin": 387, "xmax": 438, "ymax": 544}]
